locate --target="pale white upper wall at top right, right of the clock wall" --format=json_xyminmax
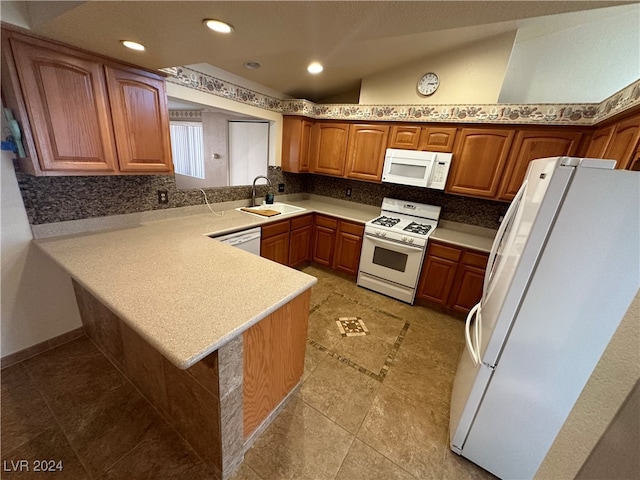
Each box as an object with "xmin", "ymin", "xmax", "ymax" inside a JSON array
[{"xmin": 498, "ymin": 4, "xmax": 640, "ymax": 103}]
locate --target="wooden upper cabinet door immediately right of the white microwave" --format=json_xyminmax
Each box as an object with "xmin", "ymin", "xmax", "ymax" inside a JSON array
[{"xmin": 445, "ymin": 128, "xmax": 515, "ymax": 198}]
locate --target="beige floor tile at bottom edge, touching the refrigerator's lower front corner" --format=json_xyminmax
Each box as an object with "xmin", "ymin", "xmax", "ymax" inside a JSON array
[{"xmin": 357, "ymin": 384, "xmax": 448, "ymax": 480}]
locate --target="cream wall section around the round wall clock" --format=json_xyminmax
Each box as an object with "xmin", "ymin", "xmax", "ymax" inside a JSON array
[{"xmin": 359, "ymin": 31, "xmax": 516, "ymax": 105}]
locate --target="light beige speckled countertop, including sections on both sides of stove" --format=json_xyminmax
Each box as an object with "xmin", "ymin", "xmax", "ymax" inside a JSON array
[{"xmin": 34, "ymin": 196, "xmax": 495, "ymax": 369}]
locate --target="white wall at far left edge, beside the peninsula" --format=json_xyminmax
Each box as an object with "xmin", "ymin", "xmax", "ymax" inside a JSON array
[{"xmin": 0, "ymin": 152, "xmax": 82, "ymax": 357}]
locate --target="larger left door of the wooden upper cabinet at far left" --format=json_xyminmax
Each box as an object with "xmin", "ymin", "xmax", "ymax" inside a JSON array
[{"xmin": 10, "ymin": 34, "xmax": 116, "ymax": 174}]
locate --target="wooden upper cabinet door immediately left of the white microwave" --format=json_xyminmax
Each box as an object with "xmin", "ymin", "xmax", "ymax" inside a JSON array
[{"xmin": 345, "ymin": 125, "xmax": 389, "ymax": 182}]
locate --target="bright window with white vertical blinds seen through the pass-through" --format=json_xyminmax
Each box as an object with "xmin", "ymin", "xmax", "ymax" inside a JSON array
[{"xmin": 169, "ymin": 122, "xmax": 205, "ymax": 178}]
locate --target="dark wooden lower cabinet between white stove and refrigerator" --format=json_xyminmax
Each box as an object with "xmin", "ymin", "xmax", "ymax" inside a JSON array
[{"xmin": 416, "ymin": 241, "xmax": 488, "ymax": 313}]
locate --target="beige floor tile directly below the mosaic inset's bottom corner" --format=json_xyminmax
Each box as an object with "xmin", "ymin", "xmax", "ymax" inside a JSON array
[{"xmin": 300, "ymin": 357, "xmax": 380, "ymax": 434}]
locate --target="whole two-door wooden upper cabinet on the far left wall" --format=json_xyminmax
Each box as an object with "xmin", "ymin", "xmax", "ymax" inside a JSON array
[{"xmin": 2, "ymin": 29, "xmax": 173, "ymax": 175}]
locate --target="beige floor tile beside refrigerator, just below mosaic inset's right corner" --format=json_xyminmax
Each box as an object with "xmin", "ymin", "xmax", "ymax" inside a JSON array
[{"xmin": 384, "ymin": 347, "xmax": 454, "ymax": 415}]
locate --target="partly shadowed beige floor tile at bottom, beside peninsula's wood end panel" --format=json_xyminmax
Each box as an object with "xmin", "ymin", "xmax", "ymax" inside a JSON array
[{"xmin": 244, "ymin": 397, "xmax": 353, "ymax": 480}]
